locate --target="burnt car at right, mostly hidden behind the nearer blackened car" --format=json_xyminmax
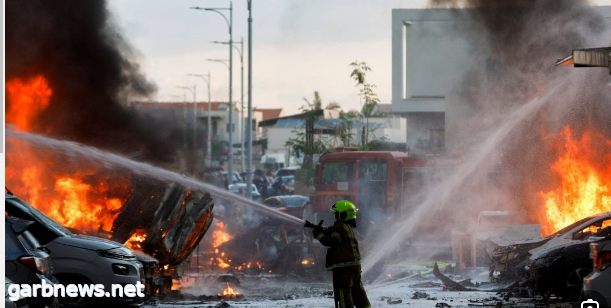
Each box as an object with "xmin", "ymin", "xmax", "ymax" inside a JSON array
[{"xmin": 490, "ymin": 212, "xmax": 611, "ymax": 281}]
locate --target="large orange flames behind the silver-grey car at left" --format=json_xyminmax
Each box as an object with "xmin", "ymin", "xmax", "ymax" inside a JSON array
[{"xmin": 5, "ymin": 76, "xmax": 131, "ymax": 232}]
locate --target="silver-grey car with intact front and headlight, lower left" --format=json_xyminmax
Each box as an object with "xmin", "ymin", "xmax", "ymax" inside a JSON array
[{"xmin": 5, "ymin": 193, "xmax": 144, "ymax": 305}]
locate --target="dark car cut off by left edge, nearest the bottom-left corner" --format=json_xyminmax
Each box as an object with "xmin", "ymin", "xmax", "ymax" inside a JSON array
[{"xmin": 4, "ymin": 216, "xmax": 58, "ymax": 307}]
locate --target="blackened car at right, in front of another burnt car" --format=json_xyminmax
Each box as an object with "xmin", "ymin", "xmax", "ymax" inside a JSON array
[{"xmin": 527, "ymin": 221, "xmax": 611, "ymax": 301}]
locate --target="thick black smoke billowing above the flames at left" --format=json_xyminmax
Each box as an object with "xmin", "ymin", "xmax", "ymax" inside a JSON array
[{"xmin": 5, "ymin": 0, "xmax": 179, "ymax": 161}]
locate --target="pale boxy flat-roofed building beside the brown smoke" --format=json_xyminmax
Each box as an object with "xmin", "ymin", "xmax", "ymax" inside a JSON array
[{"xmin": 392, "ymin": 9, "xmax": 485, "ymax": 148}]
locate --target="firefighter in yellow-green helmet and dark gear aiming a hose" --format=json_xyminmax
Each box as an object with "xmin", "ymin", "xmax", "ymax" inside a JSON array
[{"xmin": 306, "ymin": 200, "xmax": 371, "ymax": 308}]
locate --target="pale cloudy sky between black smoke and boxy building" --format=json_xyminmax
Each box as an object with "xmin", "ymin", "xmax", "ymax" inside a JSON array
[{"xmin": 109, "ymin": 0, "xmax": 611, "ymax": 115}]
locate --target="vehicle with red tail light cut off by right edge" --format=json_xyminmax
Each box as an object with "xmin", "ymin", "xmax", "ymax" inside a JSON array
[{"xmin": 583, "ymin": 241, "xmax": 611, "ymax": 307}]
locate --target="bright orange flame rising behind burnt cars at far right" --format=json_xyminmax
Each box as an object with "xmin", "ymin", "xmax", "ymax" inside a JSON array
[{"xmin": 539, "ymin": 127, "xmax": 611, "ymax": 235}]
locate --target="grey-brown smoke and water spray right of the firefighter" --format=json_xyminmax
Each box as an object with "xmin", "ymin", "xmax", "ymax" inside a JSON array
[{"xmin": 363, "ymin": 0, "xmax": 611, "ymax": 273}]
